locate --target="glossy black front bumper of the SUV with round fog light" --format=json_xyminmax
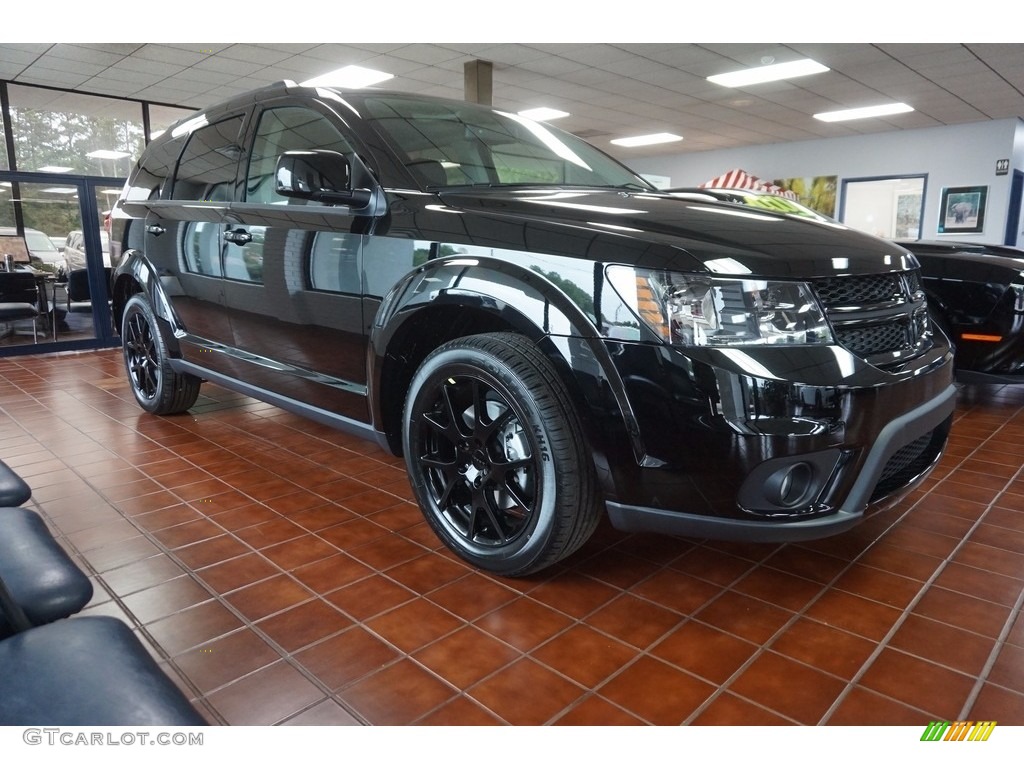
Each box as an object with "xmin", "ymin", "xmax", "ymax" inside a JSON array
[{"xmin": 605, "ymin": 344, "xmax": 956, "ymax": 541}]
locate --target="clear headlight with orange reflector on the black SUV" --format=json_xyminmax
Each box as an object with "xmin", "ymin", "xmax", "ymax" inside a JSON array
[{"xmin": 607, "ymin": 266, "xmax": 833, "ymax": 346}]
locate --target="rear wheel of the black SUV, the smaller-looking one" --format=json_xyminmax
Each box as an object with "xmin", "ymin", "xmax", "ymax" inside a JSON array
[{"xmin": 121, "ymin": 294, "xmax": 202, "ymax": 416}]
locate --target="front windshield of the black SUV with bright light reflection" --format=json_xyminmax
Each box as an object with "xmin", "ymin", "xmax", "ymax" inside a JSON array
[{"xmin": 364, "ymin": 96, "xmax": 653, "ymax": 190}]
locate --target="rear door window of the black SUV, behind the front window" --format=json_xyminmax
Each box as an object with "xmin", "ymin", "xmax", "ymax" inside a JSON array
[{"xmin": 172, "ymin": 116, "xmax": 242, "ymax": 200}]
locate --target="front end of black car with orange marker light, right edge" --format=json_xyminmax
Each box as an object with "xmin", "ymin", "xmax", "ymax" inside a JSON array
[{"xmin": 900, "ymin": 240, "xmax": 1024, "ymax": 384}]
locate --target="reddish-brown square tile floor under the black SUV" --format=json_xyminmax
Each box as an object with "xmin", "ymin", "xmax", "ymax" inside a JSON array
[{"xmin": 0, "ymin": 350, "xmax": 1024, "ymax": 726}]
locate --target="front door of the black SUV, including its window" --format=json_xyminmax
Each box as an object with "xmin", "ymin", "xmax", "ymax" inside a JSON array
[{"xmin": 224, "ymin": 103, "xmax": 369, "ymax": 421}]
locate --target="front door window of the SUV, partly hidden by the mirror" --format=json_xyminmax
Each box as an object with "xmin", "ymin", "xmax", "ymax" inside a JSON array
[{"xmin": 246, "ymin": 106, "xmax": 352, "ymax": 205}]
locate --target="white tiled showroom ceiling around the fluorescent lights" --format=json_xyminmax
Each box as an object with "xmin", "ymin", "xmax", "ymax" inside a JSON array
[{"xmin": 0, "ymin": 41, "xmax": 1024, "ymax": 161}]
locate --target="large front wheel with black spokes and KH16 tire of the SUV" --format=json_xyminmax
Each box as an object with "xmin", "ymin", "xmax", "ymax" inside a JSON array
[{"xmin": 402, "ymin": 333, "xmax": 599, "ymax": 575}]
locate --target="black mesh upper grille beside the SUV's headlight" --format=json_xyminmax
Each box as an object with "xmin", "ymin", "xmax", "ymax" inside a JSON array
[{"xmin": 812, "ymin": 270, "xmax": 929, "ymax": 366}]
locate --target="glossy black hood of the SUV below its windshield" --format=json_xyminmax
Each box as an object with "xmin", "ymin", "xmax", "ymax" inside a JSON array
[{"xmin": 439, "ymin": 186, "xmax": 918, "ymax": 279}]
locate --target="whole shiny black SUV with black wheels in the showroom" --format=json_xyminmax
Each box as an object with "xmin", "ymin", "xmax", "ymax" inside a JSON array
[{"xmin": 112, "ymin": 83, "xmax": 955, "ymax": 575}]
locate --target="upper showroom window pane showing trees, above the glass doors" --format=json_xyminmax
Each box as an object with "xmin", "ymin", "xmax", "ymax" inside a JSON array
[{"xmin": 7, "ymin": 84, "xmax": 144, "ymax": 178}]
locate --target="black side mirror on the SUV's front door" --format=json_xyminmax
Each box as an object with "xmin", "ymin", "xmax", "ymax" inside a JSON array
[{"xmin": 273, "ymin": 150, "xmax": 373, "ymax": 208}]
